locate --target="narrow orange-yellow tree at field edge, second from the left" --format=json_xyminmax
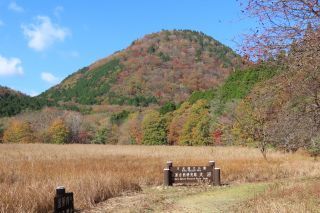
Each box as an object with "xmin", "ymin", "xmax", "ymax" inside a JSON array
[{"xmin": 48, "ymin": 118, "xmax": 70, "ymax": 144}]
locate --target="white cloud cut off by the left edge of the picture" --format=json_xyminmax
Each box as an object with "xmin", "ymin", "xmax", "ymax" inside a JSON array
[{"xmin": 0, "ymin": 55, "xmax": 23, "ymax": 76}]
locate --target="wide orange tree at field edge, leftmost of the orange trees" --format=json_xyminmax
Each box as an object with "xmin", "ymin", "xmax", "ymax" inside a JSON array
[{"xmin": 3, "ymin": 120, "xmax": 35, "ymax": 143}]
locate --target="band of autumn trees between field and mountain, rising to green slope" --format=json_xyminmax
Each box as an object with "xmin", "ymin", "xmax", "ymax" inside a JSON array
[{"xmin": 0, "ymin": 62, "xmax": 282, "ymax": 145}]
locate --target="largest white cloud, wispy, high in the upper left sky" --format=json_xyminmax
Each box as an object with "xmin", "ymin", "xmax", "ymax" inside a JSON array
[{"xmin": 22, "ymin": 16, "xmax": 70, "ymax": 51}]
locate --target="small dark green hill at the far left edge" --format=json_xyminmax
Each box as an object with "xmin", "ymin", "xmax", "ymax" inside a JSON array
[{"xmin": 0, "ymin": 86, "xmax": 45, "ymax": 117}]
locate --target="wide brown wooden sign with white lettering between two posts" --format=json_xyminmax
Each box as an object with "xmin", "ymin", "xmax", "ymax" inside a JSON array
[{"xmin": 164, "ymin": 161, "xmax": 220, "ymax": 186}]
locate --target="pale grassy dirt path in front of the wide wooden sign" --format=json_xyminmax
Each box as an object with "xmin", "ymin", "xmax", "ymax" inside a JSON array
[{"xmin": 82, "ymin": 183, "xmax": 268, "ymax": 213}]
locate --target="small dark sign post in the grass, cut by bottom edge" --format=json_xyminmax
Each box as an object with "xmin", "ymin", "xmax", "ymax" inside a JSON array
[{"xmin": 54, "ymin": 187, "xmax": 74, "ymax": 213}]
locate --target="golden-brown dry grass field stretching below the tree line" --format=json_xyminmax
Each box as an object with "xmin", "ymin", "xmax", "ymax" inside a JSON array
[{"xmin": 0, "ymin": 144, "xmax": 320, "ymax": 212}]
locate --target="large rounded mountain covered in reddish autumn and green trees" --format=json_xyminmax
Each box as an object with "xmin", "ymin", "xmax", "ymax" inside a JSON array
[{"xmin": 40, "ymin": 30, "xmax": 241, "ymax": 106}]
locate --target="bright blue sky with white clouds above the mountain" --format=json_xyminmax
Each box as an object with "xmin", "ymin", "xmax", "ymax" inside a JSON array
[{"xmin": 0, "ymin": 0, "xmax": 255, "ymax": 95}]
